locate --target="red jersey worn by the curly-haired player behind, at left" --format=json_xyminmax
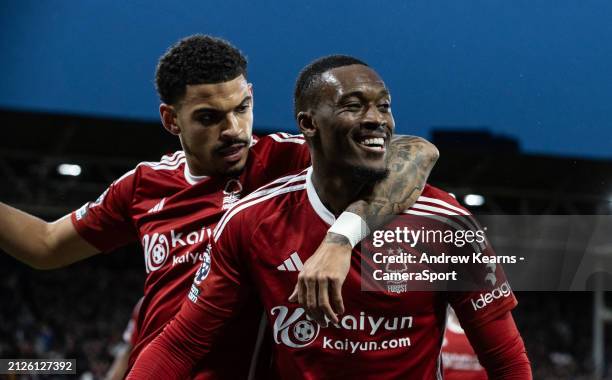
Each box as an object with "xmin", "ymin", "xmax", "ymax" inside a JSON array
[{"xmin": 71, "ymin": 133, "xmax": 310, "ymax": 378}]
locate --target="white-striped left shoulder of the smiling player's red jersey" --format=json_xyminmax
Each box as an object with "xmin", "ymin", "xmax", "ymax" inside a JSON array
[{"xmin": 213, "ymin": 170, "xmax": 307, "ymax": 241}]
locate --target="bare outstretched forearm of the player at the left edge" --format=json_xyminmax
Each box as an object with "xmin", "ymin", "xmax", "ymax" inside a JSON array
[{"xmin": 0, "ymin": 203, "xmax": 98, "ymax": 269}]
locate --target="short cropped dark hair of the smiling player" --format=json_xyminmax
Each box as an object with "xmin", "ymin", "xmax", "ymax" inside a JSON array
[{"xmin": 293, "ymin": 54, "xmax": 369, "ymax": 117}]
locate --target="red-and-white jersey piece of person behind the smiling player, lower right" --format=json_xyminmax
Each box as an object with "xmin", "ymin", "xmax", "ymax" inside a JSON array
[{"xmin": 442, "ymin": 315, "xmax": 487, "ymax": 380}]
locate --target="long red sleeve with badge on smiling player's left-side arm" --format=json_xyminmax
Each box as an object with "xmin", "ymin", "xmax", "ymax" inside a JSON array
[{"xmin": 128, "ymin": 211, "xmax": 252, "ymax": 379}]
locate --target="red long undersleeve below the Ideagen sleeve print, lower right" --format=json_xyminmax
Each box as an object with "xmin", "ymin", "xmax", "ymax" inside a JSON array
[{"xmin": 461, "ymin": 312, "xmax": 532, "ymax": 380}]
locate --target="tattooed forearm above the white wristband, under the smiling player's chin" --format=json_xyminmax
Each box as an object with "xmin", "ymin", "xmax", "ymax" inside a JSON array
[{"xmin": 346, "ymin": 136, "xmax": 439, "ymax": 220}]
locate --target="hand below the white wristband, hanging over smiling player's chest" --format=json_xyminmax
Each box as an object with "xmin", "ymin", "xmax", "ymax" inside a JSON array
[{"xmin": 289, "ymin": 232, "xmax": 352, "ymax": 326}]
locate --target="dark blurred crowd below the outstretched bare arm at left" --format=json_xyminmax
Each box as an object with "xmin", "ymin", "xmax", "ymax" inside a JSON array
[{"xmin": 0, "ymin": 247, "xmax": 144, "ymax": 379}]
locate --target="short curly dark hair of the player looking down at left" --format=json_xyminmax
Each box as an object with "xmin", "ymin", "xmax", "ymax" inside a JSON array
[{"xmin": 155, "ymin": 34, "xmax": 247, "ymax": 104}]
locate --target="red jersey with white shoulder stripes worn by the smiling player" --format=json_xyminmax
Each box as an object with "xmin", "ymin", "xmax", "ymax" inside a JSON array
[{"xmin": 159, "ymin": 169, "xmax": 516, "ymax": 379}]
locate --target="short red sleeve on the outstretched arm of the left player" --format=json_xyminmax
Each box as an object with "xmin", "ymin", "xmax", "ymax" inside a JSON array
[{"xmin": 70, "ymin": 169, "xmax": 138, "ymax": 252}]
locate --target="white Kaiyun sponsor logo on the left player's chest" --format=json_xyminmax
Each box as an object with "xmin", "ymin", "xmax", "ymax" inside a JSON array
[{"xmin": 142, "ymin": 228, "xmax": 212, "ymax": 273}]
